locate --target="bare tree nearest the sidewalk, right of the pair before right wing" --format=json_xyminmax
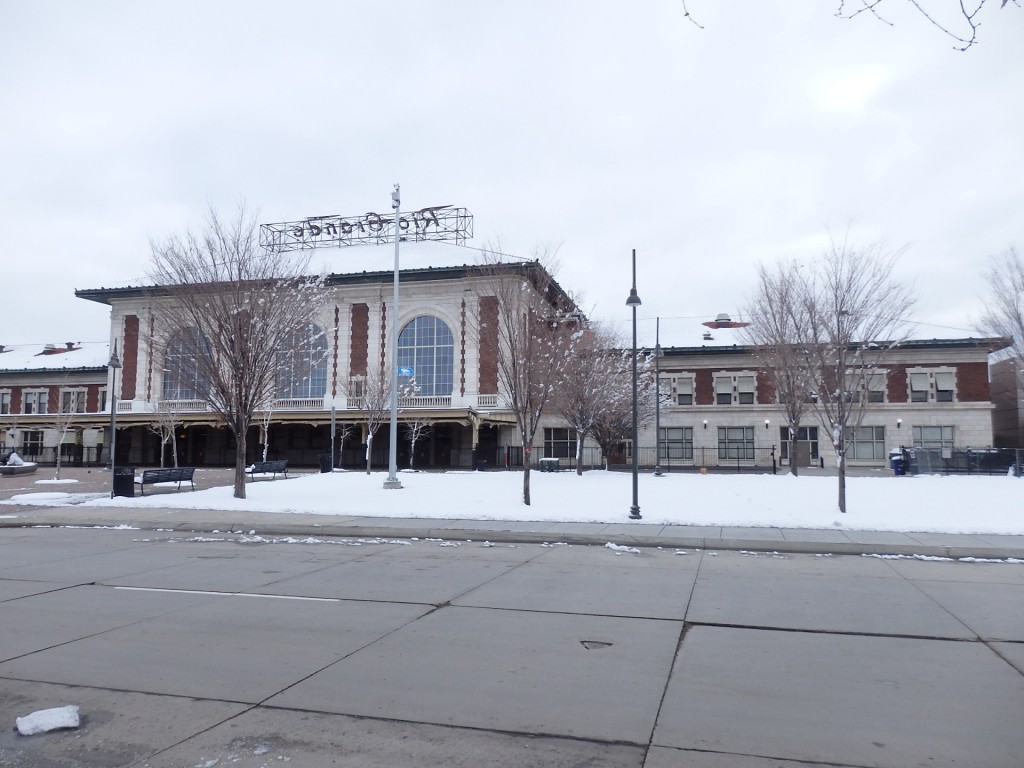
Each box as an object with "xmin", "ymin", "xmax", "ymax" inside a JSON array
[{"xmin": 800, "ymin": 240, "xmax": 914, "ymax": 513}]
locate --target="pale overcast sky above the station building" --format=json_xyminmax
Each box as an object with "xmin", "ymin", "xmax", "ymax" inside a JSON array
[{"xmin": 0, "ymin": 0, "xmax": 1024, "ymax": 345}]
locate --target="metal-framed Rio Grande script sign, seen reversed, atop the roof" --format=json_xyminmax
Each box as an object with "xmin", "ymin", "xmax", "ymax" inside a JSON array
[{"xmin": 259, "ymin": 206, "xmax": 473, "ymax": 251}]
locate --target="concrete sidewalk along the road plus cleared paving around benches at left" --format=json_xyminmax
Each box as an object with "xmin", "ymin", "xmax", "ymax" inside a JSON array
[{"xmin": 0, "ymin": 467, "xmax": 1024, "ymax": 559}]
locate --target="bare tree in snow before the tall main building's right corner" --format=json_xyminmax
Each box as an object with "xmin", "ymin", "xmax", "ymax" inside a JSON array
[{"xmin": 468, "ymin": 249, "xmax": 583, "ymax": 506}]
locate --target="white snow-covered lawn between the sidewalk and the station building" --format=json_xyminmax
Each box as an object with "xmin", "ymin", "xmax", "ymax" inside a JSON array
[{"xmin": 8, "ymin": 471, "xmax": 1024, "ymax": 535}]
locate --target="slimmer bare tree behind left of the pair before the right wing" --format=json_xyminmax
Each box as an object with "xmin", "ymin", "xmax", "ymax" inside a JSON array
[{"xmin": 740, "ymin": 260, "xmax": 820, "ymax": 475}]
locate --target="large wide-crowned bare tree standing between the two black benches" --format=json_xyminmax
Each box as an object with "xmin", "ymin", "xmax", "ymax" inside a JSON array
[{"xmin": 152, "ymin": 206, "xmax": 323, "ymax": 499}]
